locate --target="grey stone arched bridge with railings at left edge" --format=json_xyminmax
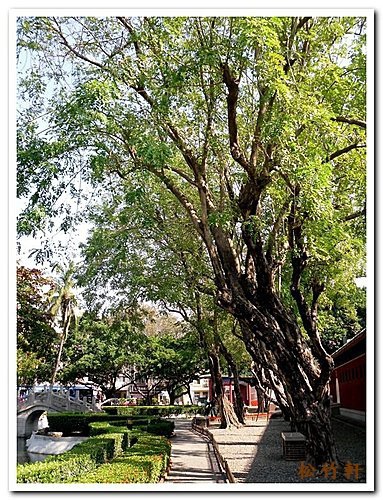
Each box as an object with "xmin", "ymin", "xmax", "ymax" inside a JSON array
[{"xmin": 17, "ymin": 390, "xmax": 100, "ymax": 437}]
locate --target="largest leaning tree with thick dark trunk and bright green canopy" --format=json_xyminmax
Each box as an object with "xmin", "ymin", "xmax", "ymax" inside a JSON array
[{"xmin": 18, "ymin": 17, "xmax": 366, "ymax": 464}]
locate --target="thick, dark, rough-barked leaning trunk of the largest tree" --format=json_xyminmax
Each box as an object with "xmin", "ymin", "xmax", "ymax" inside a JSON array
[{"xmin": 208, "ymin": 228, "xmax": 337, "ymax": 465}]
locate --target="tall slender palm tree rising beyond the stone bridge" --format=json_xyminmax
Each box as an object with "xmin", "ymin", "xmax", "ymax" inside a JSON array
[{"xmin": 49, "ymin": 262, "xmax": 79, "ymax": 386}]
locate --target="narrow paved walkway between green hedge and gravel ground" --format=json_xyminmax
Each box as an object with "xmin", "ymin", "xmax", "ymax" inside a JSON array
[{"xmin": 165, "ymin": 418, "xmax": 226, "ymax": 483}]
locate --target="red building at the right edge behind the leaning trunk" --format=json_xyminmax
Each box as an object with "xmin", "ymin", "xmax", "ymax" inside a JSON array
[{"xmin": 330, "ymin": 330, "xmax": 366, "ymax": 418}]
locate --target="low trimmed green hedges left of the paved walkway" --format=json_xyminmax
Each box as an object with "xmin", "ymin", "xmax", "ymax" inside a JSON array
[{"xmin": 17, "ymin": 419, "xmax": 174, "ymax": 483}]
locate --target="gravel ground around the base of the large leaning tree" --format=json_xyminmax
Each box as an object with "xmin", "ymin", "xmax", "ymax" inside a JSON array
[{"xmin": 209, "ymin": 418, "xmax": 366, "ymax": 483}]
